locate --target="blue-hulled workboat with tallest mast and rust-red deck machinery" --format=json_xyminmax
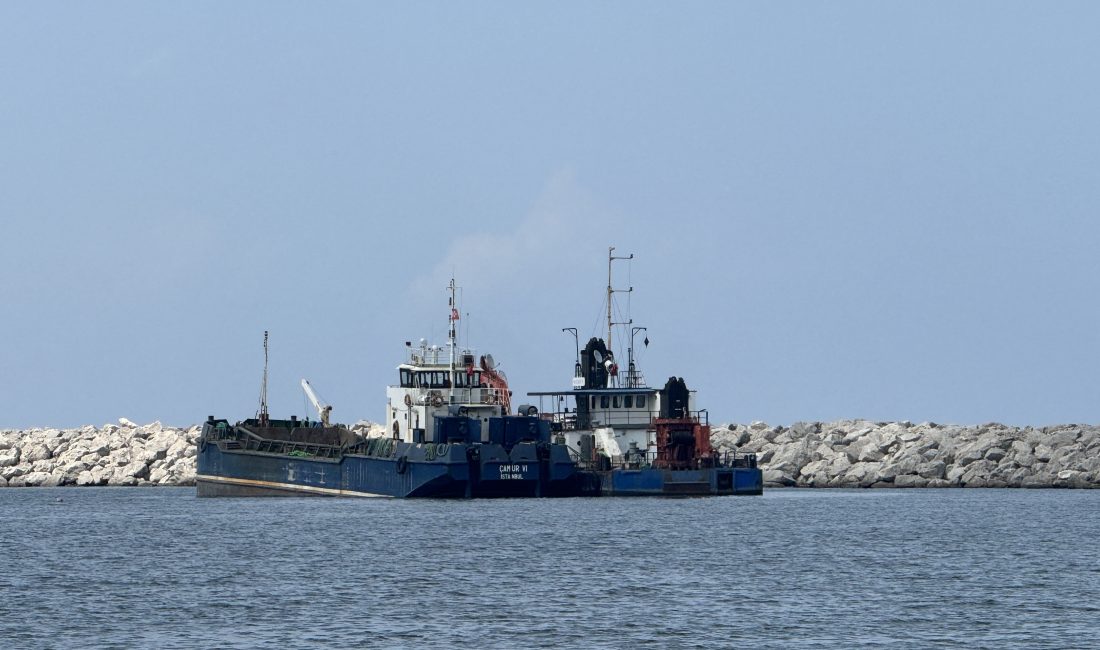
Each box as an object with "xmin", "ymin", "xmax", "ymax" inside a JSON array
[{"xmin": 528, "ymin": 246, "xmax": 763, "ymax": 496}]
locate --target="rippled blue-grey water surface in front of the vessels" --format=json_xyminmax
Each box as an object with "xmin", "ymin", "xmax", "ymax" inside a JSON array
[{"xmin": 0, "ymin": 488, "xmax": 1100, "ymax": 648}]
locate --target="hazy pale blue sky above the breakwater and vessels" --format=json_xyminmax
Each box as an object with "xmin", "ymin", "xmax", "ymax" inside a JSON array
[{"xmin": 0, "ymin": 1, "xmax": 1100, "ymax": 428}]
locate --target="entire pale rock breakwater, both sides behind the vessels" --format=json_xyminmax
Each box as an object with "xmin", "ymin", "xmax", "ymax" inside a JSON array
[{"xmin": 0, "ymin": 418, "xmax": 1100, "ymax": 487}]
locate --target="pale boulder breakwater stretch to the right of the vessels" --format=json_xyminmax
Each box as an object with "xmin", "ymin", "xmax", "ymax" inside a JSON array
[{"xmin": 712, "ymin": 420, "xmax": 1100, "ymax": 487}]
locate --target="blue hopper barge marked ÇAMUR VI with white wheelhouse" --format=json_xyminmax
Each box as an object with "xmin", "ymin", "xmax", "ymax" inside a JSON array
[{"xmin": 196, "ymin": 279, "xmax": 598, "ymax": 498}]
